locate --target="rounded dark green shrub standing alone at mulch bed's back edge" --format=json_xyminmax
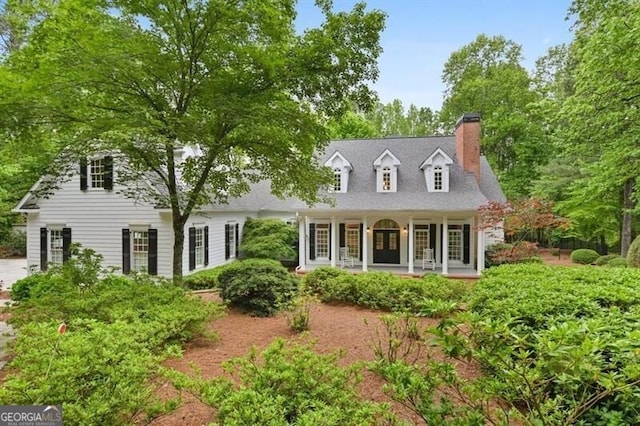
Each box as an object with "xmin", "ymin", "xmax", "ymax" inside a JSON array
[{"xmin": 218, "ymin": 259, "xmax": 298, "ymax": 316}]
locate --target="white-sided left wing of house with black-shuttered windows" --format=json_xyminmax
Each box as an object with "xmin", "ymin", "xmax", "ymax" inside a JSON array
[{"xmin": 14, "ymin": 158, "xmax": 258, "ymax": 277}]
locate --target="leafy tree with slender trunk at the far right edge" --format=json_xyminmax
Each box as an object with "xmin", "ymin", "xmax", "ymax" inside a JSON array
[{"xmin": 562, "ymin": 0, "xmax": 640, "ymax": 256}]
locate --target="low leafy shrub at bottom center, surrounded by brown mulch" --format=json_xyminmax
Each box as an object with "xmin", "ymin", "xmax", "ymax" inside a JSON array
[{"xmin": 166, "ymin": 339, "xmax": 390, "ymax": 426}]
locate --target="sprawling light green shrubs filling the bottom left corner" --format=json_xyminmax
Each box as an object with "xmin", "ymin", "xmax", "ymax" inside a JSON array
[{"xmin": 0, "ymin": 256, "xmax": 222, "ymax": 424}]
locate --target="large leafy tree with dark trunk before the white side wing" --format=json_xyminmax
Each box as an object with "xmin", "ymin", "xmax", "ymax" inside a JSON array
[{"xmin": 0, "ymin": 0, "xmax": 385, "ymax": 282}]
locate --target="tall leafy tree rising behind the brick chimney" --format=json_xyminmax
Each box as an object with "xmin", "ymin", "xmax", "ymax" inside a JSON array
[{"xmin": 440, "ymin": 34, "xmax": 549, "ymax": 198}]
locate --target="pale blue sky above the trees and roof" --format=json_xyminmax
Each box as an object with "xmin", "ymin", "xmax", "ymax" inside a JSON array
[{"xmin": 297, "ymin": 0, "xmax": 572, "ymax": 110}]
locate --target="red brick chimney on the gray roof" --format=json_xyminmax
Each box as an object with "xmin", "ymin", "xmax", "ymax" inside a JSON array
[{"xmin": 456, "ymin": 112, "xmax": 480, "ymax": 183}]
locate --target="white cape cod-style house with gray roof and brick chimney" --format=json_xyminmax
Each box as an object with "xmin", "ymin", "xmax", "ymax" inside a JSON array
[{"xmin": 14, "ymin": 114, "xmax": 505, "ymax": 276}]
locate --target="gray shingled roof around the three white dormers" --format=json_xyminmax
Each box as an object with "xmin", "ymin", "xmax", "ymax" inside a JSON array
[{"xmin": 211, "ymin": 136, "xmax": 506, "ymax": 212}]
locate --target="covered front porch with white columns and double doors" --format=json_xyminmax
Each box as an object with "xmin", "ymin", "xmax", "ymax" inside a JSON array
[{"xmin": 298, "ymin": 212, "xmax": 486, "ymax": 277}]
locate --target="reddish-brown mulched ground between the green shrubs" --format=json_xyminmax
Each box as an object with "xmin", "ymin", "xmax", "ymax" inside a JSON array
[{"xmin": 0, "ymin": 253, "xmax": 571, "ymax": 426}]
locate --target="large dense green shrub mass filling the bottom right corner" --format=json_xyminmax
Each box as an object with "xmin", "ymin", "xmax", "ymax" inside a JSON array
[{"xmin": 460, "ymin": 260, "xmax": 640, "ymax": 424}]
